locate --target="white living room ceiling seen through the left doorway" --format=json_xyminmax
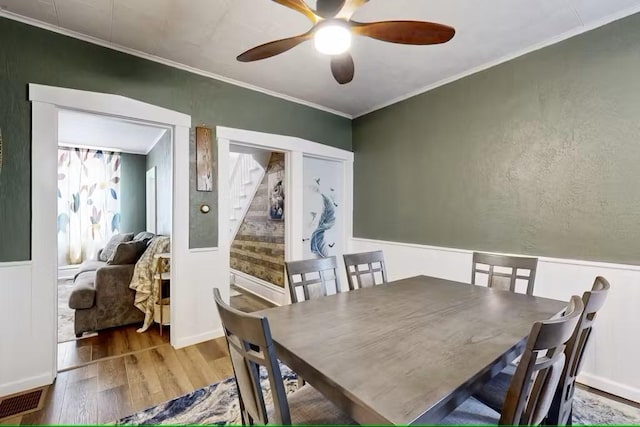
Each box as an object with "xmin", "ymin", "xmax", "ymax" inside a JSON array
[{"xmin": 58, "ymin": 111, "xmax": 167, "ymax": 154}]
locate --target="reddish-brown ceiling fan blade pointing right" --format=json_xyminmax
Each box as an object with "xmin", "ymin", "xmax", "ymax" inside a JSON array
[{"xmin": 351, "ymin": 21, "xmax": 456, "ymax": 45}]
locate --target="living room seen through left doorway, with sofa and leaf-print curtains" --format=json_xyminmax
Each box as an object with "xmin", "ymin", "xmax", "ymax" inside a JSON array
[{"xmin": 56, "ymin": 110, "xmax": 172, "ymax": 370}]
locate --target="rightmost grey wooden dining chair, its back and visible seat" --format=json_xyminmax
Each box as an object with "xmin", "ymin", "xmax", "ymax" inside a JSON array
[{"xmin": 475, "ymin": 276, "xmax": 610, "ymax": 425}]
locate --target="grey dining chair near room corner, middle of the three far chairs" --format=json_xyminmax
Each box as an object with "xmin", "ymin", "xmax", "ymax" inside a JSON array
[{"xmin": 342, "ymin": 251, "xmax": 388, "ymax": 291}]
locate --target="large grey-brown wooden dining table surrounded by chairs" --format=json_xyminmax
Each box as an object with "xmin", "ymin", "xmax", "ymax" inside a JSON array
[{"xmin": 258, "ymin": 276, "xmax": 566, "ymax": 424}]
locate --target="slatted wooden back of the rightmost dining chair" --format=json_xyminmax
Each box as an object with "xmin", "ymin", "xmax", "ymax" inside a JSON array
[{"xmin": 548, "ymin": 276, "xmax": 611, "ymax": 425}]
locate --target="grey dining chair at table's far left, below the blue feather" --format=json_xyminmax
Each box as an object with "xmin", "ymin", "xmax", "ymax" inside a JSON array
[{"xmin": 284, "ymin": 256, "xmax": 340, "ymax": 303}]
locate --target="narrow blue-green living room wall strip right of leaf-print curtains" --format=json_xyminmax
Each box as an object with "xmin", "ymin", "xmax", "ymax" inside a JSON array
[{"xmin": 120, "ymin": 153, "xmax": 147, "ymax": 233}]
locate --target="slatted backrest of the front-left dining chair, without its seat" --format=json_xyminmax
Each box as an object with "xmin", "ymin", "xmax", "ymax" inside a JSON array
[{"xmin": 213, "ymin": 288, "xmax": 291, "ymax": 425}]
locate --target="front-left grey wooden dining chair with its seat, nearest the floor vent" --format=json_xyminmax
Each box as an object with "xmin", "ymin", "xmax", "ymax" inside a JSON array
[{"xmin": 213, "ymin": 288, "xmax": 355, "ymax": 425}]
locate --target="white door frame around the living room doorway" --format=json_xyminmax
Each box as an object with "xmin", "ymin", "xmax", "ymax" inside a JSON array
[{"xmin": 29, "ymin": 84, "xmax": 191, "ymax": 387}]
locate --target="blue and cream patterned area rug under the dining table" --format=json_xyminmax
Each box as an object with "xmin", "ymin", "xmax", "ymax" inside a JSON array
[{"xmin": 117, "ymin": 365, "xmax": 640, "ymax": 425}]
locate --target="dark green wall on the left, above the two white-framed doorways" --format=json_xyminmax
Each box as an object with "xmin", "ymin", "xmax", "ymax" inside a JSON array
[{"xmin": 0, "ymin": 18, "xmax": 351, "ymax": 262}]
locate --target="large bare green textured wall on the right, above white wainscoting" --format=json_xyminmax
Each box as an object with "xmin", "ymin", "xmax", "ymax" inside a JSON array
[{"xmin": 353, "ymin": 14, "xmax": 640, "ymax": 264}]
